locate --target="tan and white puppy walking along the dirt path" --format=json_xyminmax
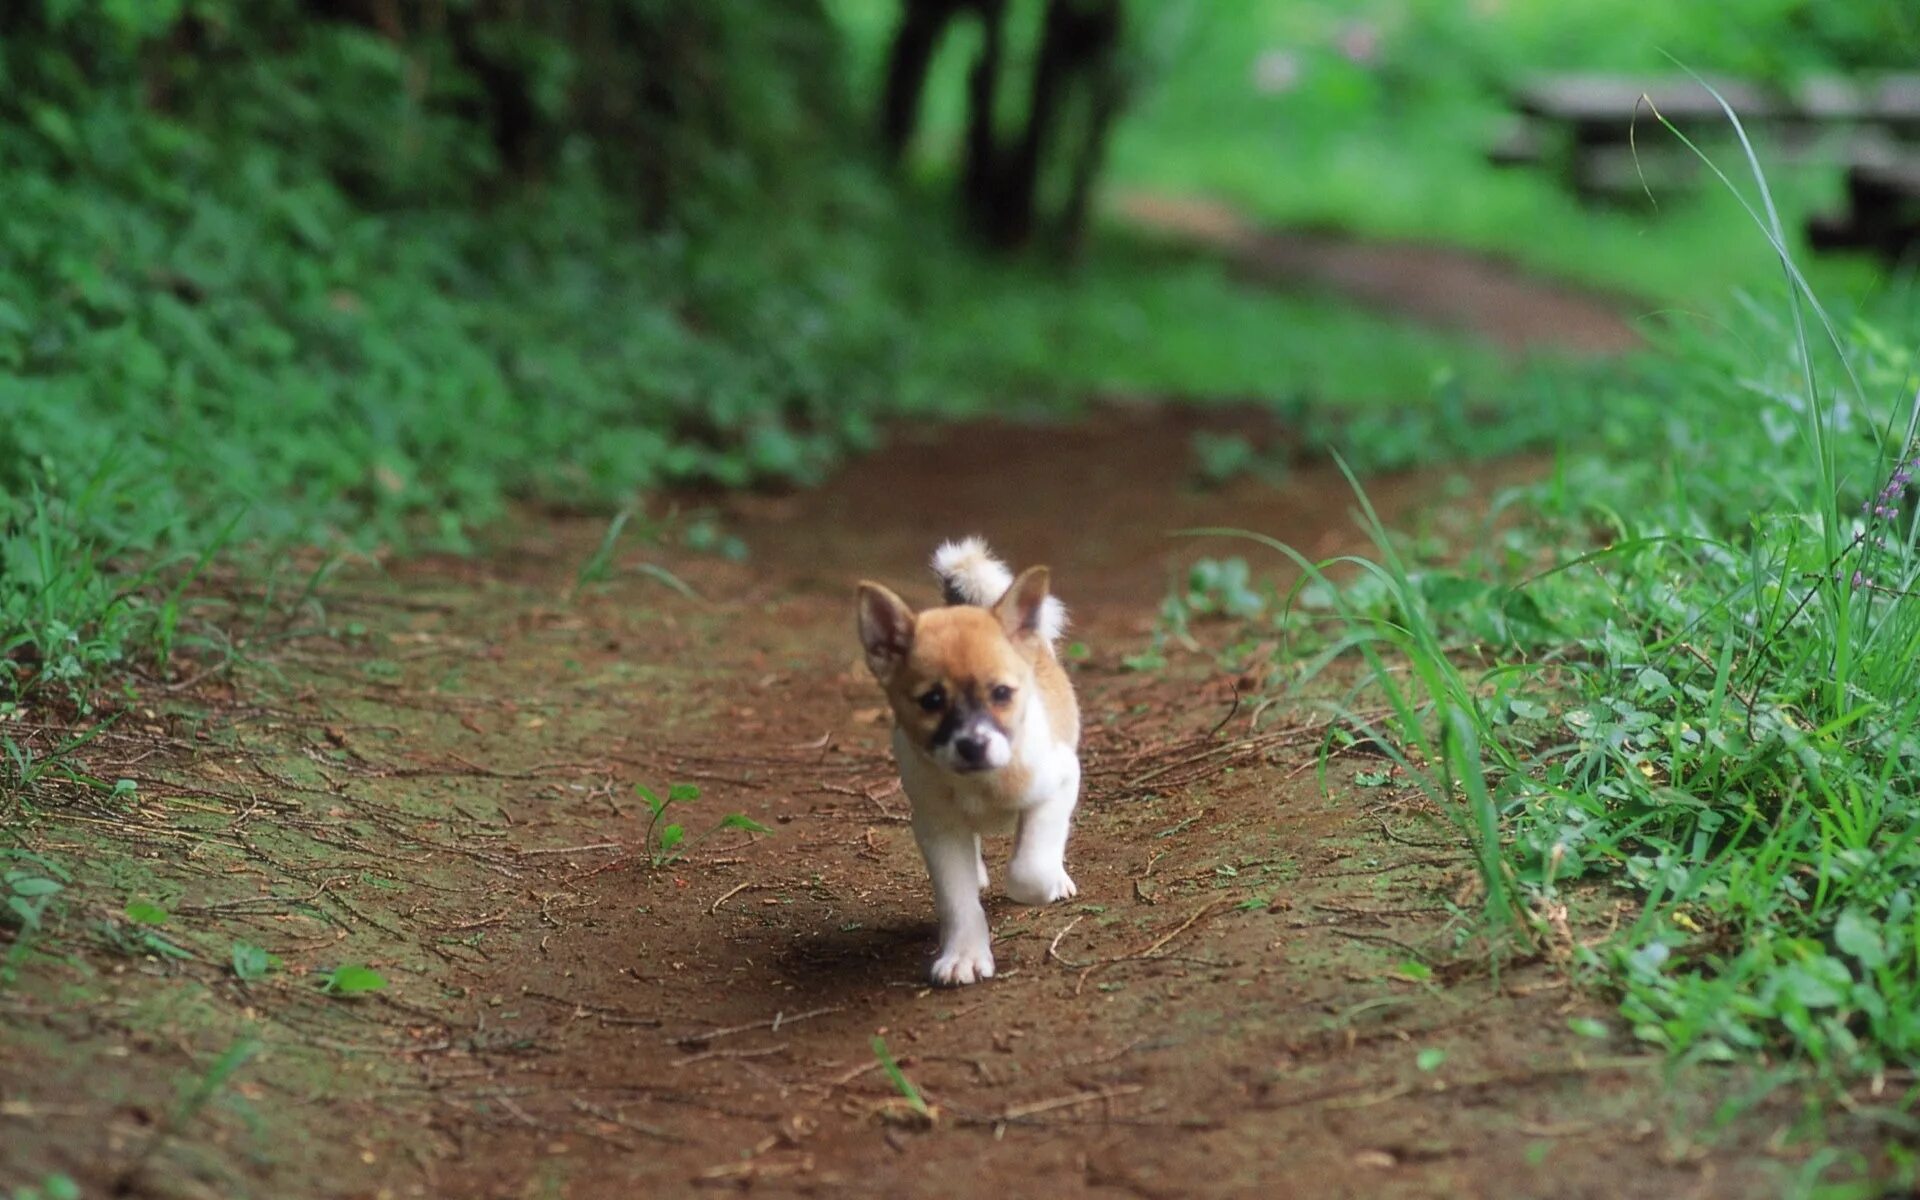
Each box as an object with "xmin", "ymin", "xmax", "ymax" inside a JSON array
[{"xmin": 858, "ymin": 538, "xmax": 1081, "ymax": 985}]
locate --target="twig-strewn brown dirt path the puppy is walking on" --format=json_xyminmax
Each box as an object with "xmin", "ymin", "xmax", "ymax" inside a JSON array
[{"xmin": 0, "ymin": 411, "xmax": 1809, "ymax": 1198}]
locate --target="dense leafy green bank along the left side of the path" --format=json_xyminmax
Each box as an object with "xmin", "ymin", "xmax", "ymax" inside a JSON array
[{"xmin": 0, "ymin": 0, "xmax": 899, "ymax": 701}]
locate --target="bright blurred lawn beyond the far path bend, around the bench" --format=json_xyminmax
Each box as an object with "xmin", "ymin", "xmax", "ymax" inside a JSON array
[{"xmin": 831, "ymin": 0, "xmax": 1896, "ymax": 307}]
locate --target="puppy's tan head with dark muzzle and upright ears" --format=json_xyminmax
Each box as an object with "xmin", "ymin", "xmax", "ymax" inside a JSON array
[{"xmin": 858, "ymin": 566, "xmax": 1046, "ymax": 774}]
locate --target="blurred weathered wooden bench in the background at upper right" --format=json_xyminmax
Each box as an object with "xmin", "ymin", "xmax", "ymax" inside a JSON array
[{"xmin": 1488, "ymin": 75, "xmax": 1920, "ymax": 257}]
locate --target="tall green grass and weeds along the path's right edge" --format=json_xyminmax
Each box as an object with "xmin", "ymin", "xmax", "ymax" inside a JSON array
[{"xmin": 1213, "ymin": 121, "xmax": 1920, "ymax": 1075}]
